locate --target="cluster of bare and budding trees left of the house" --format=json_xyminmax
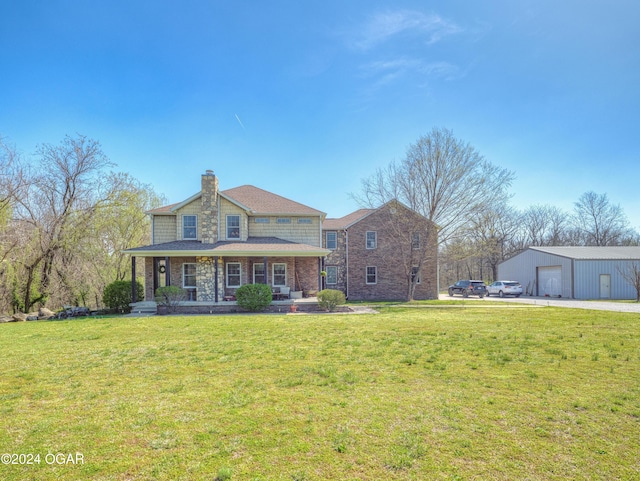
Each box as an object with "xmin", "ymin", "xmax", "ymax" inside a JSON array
[{"xmin": 0, "ymin": 135, "xmax": 164, "ymax": 313}]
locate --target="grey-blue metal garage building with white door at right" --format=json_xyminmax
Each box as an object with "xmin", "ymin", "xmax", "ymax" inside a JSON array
[{"xmin": 498, "ymin": 246, "xmax": 640, "ymax": 299}]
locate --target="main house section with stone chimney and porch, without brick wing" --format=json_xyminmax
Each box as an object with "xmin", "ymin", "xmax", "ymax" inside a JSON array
[{"xmin": 126, "ymin": 171, "xmax": 329, "ymax": 302}]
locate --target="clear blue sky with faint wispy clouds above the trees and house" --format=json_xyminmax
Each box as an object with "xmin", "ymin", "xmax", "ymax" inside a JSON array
[{"xmin": 0, "ymin": 0, "xmax": 640, "ymax": 228}]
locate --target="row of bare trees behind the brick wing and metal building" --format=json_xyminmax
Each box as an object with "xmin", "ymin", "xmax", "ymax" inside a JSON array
[{"xmin": 353, "ymin": 128, "xmax": 640, "ymax": 286}]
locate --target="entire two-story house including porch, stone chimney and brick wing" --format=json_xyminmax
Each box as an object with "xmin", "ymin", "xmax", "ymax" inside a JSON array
[{"xmin": 126, "ymin": 171, "xmax": 437, "ymax": 303}]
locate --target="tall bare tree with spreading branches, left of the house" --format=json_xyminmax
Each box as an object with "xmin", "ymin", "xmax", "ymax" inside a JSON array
[{"xmin": 15, "ymin": 136, "xmax": 111, "ymax": 311}]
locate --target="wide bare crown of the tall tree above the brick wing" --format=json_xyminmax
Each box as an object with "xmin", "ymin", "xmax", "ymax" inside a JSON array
[{"xmin": 354, "ymin": 128, "xmax": 513, "ymax": 243}]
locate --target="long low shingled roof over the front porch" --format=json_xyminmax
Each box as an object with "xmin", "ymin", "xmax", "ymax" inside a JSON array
[{"xmin": 124, "ymin": 237, "xmax": 331, "ymax": 257}]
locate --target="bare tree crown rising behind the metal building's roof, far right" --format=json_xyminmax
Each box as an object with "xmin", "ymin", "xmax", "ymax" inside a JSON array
[{"xmin": 573, "ymin": 191, "xmax": 633, "ymax": 246}]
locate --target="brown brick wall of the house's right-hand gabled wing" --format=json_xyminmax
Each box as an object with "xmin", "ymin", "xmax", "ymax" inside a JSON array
[{"xmin": 345, "ymin": 205, "xmax": 437, "ymax": 300}]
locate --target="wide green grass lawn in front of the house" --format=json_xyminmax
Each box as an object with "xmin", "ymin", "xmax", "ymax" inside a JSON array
[{"xmin": 0, "ymin": 306, "xmax": 640, "ymax": 481}]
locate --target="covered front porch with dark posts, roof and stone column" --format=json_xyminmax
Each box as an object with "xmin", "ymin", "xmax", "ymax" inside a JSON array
[{"xmin": 127, "ymin": 238, "xmax": 329, "ymax": 302}]
